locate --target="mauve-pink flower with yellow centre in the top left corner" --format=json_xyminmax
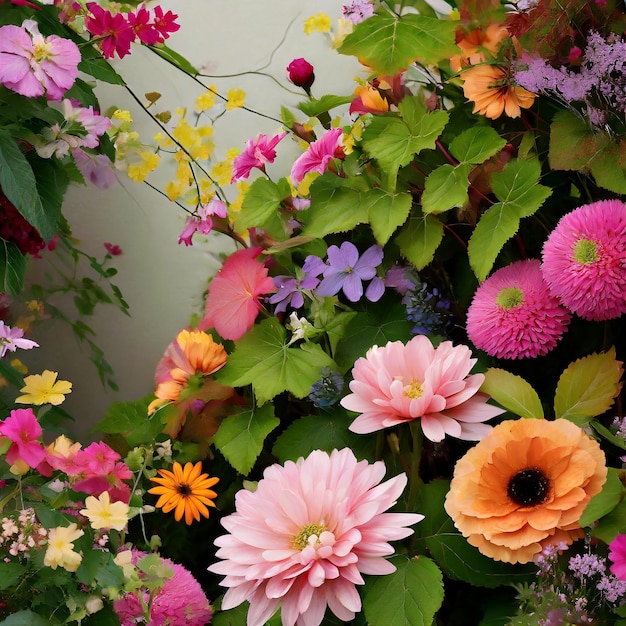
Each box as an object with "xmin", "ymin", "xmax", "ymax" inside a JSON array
[{"xmin": 0, "ymin": 20, "xmax": 81, "ymax": 100}]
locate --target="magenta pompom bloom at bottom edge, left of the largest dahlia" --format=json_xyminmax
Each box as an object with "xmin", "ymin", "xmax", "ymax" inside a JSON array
[{"xmin": 114, "ymin": 550, "xmax": 213, "ymax": 626}]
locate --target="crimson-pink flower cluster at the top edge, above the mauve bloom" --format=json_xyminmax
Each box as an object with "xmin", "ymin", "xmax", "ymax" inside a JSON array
[{"xmin": 85, "ymin": 2, "xmax": 180, "ymax": 59}]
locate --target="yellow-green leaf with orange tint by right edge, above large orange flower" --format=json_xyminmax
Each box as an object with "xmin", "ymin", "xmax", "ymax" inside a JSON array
[{"xmin": 554, "ymin": 346, "xmax": 623, "ymax": 420}]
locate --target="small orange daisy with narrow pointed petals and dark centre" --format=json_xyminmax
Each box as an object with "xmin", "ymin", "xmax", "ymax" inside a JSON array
[{"xmin": 148, "ymin": 461, "xmax": 219, "ymax": 524}]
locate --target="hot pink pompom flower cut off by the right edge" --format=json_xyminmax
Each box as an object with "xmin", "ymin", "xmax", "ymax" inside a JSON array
[{"xmin": 541, "ymin": 200, "xmax": 626, "ymax": 321}]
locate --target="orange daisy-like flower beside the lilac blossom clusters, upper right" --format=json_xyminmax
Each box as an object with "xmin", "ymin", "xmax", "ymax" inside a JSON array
[{"xmin": 461, "ymin": 63, "xmax": 535, "ymax": 120}]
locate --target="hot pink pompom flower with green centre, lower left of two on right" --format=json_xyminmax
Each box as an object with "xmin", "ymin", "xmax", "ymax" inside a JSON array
[{"xmin": 467, "ymin": 259, "xmax": 572, "ymax": 359}]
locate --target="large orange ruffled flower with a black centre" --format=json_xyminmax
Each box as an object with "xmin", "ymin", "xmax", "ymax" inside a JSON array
[{"xmin": 445, "ymin": 418, "xmax": 607, "ymax": 563}]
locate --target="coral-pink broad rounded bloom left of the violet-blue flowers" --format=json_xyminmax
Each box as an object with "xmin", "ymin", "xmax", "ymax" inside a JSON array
[{"xmin": 198, "ymin": 248, "xmax": 276, "ymax": 341}]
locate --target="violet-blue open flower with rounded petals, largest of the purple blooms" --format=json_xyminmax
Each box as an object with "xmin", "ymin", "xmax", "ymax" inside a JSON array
[{"xmin": 317, "ymin": 241, "xmax": 385, "ymax": 302}]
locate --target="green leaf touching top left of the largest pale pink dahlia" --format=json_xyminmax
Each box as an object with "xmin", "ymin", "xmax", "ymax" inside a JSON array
[{"xmin": 213, "ymin": 404, "xmax": 280, "ymax": 476}]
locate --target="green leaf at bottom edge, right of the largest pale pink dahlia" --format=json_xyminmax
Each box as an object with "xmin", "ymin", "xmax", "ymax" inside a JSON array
[{"xmin": 363, "ymin": 556, "xmax": 443, "ymax": 626}]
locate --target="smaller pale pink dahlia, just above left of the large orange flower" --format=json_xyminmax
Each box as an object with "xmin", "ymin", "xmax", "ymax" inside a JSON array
[{"xmin": 341, "ymin": 335, "xmax": 504, "ymax": 441}]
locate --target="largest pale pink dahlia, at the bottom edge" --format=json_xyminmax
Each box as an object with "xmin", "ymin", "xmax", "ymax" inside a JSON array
[{"xmin": 209, "ymin": 448, "xmax": 424, "ymax": 626}]
